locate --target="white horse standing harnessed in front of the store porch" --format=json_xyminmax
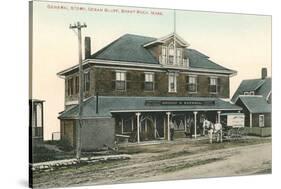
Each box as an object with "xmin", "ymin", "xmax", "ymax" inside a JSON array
[{"xmin": 203, "ymin": 119, "xmax": 222, "ymax": 143}]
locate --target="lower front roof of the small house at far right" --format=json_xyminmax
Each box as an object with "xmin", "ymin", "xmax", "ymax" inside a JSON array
[{"xmin": 239, "ymin": 96, "xmax": 271, "ymax": 113}]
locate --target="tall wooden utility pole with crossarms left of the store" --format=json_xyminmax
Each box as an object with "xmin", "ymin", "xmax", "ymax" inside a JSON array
[{"xmin": 69, "ymin": 22, "xmax": 87, "ymax": 160}]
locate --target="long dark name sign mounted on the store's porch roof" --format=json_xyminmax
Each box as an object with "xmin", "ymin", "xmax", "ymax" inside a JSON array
[{"xmin": 145, "ymin": 100, "xmax": 215, "ymax": 106}]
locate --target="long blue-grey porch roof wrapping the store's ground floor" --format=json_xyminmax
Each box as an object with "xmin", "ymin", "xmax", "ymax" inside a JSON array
[{"xmin": 59, "ymin": 96, "xmax": 242, "ymax": 119}]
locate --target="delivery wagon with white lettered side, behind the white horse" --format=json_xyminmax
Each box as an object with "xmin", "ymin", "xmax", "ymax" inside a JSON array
[{"xmin": 221, "ymin": 113, "xmax": 247, "ymax": 139}]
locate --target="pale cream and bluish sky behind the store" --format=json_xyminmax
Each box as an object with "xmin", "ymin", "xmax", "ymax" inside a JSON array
[{"xmin": 32, "ymin": 1, "xmax": 271, "ymax": 140}]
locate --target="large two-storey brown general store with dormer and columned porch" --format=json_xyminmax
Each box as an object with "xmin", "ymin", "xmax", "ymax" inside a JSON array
[{"xmin": 58, "ymin": 33, "xmax": 242, "ymax": 149}]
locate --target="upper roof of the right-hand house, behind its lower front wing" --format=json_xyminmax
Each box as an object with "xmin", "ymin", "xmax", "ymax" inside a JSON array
[{"xmin": 231, "ymin": 77, "xmax": 271, "ymax": 102}]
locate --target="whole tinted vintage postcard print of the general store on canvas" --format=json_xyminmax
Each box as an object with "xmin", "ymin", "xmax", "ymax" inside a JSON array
[{"xmin": 29, "ymin": 1, "xmax": 272, "ymax": 188}]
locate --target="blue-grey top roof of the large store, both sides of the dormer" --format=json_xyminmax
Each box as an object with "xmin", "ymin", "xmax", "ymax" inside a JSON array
[{"xmin": 91, "ymin": 34, "xmax": 231, "ymax": 71}]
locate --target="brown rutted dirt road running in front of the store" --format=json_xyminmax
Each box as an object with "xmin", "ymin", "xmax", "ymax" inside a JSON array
[{"xmin": 31, "ymin": 139, "xmax": 271, "ymax": 187}]
